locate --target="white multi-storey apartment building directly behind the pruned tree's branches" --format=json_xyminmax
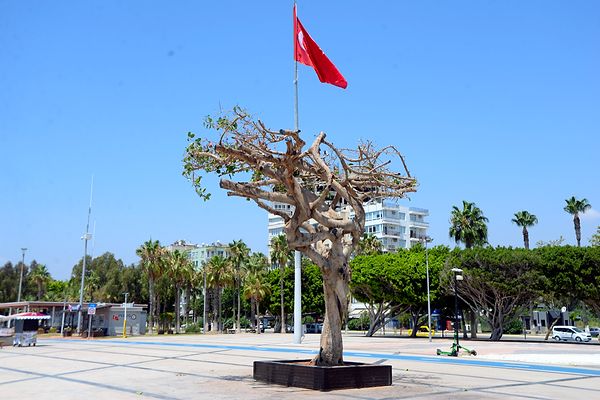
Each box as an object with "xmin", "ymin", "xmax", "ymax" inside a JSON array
[{"xmin": 268, "ymin": 199, "xmax": 429, "ymax": 251}]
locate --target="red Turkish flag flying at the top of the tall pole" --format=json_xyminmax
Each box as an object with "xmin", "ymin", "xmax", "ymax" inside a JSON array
[{"xmin": 294, "ymin": 5, "xmax": 348, "ymax": 89}]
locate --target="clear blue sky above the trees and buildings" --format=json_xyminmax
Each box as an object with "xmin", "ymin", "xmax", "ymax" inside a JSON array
[{"xmin": 0, "ymin": 0, "xmax": 600, "ymax": 279}]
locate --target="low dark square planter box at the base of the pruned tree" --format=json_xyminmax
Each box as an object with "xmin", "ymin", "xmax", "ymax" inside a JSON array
[{"xmin": 254, "ymin": 360, "xmax": 392, "ymax": 391}]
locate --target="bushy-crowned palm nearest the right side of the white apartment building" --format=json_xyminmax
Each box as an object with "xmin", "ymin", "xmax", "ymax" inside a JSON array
[{"xmin": 449, "ymin": 200, "xmax": 488, "ymax": 249}]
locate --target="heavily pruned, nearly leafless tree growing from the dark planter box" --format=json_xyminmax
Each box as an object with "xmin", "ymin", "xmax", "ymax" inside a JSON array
[{"xmin": 184, "ymin": 108, "xmax": 416, "ymax": 365}]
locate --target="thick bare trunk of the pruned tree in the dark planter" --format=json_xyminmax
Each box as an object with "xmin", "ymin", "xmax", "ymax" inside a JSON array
[{"xmin": 312, "ymin": 257, "xmax": 349, "ymax": 366}]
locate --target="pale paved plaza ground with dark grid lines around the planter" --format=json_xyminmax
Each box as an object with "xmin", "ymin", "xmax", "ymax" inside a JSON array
[{"xmin": 0, "ymin": 333, "xmax": 600, "ymax": 400}]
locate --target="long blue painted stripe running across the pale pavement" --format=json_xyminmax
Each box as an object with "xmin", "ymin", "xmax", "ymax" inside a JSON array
[{"xmin": 44, "ymin": 339, "xmax": 600, "ymax": 376}]
